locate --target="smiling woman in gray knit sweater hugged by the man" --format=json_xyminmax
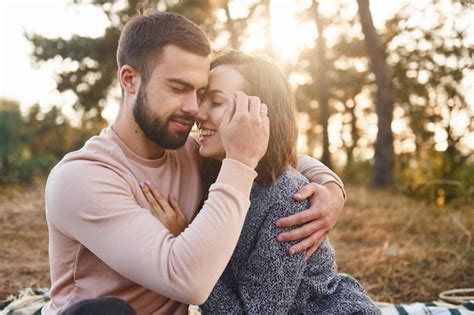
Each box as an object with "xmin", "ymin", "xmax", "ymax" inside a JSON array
[{"xmin": 145, "ymin": 51, "xmax": 380, "ymax": 314}]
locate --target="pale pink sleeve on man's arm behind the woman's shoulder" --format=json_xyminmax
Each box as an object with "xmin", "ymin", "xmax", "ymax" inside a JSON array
[{"xmin": 297, "ymin": 155, "xmax": 347, "ymax": 199}]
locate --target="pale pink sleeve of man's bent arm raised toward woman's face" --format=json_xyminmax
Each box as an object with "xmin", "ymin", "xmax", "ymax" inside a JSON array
[{"xmin": 46, "ymin": 159, "xmax": 256, "ymax": 304}]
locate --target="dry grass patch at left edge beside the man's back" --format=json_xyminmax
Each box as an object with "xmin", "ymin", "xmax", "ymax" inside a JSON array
[{"xmin": 0, "ymin": 184, "xmax": 50, "ymax": 301}]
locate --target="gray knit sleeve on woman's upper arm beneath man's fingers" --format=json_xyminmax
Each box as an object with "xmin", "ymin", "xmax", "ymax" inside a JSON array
[{"xmin": 211, "ymin": 197, "xmax": 307, "ymax": 314}]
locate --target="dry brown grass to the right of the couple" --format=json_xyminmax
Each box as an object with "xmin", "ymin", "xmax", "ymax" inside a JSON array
[{"xmin": 331, "ymin": 187, "xmax": 474, "ymax": 303}]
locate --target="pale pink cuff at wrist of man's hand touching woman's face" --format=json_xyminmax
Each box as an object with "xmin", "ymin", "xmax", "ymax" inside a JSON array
[{"xmin": 216, "ymin": 159, "xmax": 257, "ymax": 196}]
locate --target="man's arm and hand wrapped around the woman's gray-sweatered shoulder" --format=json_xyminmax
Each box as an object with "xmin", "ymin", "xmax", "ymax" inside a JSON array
[{"xmin": 276, "ymin": 155, "xmax": 346, "ymax": 258}]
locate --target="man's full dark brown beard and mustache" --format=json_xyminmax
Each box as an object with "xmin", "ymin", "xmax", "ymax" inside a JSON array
[{"xmin": 133, "ymin": 85, "xmax": 194, "ymax": 150}]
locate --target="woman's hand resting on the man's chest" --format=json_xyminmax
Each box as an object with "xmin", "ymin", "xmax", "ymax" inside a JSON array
[{"xmin": 140, "ymin": 181, "xmax": 187, "ymax": 236}]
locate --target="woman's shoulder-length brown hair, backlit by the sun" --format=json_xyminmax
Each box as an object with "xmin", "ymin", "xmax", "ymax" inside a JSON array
[{"xmin": 201, "ymin": 50, "xmax": 298, "ymax": 192}]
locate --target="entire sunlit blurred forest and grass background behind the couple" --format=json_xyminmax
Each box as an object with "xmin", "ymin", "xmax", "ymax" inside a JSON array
[{"xmin": 0, "ymin": 0, "xmax": 474, "ymax": 302}]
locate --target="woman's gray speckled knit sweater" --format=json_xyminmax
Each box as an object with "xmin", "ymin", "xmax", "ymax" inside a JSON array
[{"xmin": 201, "ymin": 168, "xmax": 380, "ymax": 314}]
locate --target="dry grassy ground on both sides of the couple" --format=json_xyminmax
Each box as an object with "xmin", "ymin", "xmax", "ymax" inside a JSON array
[{"xmin": 0, "ymin": 183, "xmax": 474, "ymax": 303}]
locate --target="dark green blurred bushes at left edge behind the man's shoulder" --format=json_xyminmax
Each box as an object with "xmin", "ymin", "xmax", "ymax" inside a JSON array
[{"xmin": 0, "ymin": 99, "xmax": 97, "ymax": 185}]
